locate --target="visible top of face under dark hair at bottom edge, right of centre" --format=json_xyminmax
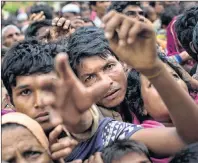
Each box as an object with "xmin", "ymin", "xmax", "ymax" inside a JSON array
[{"xmin": 112, "ymin": 152, "xmax": 151, "ymax": 163}]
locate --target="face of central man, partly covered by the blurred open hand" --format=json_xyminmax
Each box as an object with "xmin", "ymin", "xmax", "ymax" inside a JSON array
[{"xmin": 77, "ymin": 55, "xmax": 127, "ymax": 108}]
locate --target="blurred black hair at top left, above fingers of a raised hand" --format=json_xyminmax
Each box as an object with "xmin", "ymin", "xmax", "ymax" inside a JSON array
[{"xmin": 29, "ymin": 4, "xmax": 53, "ymax": 19}]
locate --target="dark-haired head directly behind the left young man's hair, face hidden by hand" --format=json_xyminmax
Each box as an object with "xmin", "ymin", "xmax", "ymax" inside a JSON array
[{"xmin": 25, "ymin": 19, "xmax": 52, "ymax": 40}]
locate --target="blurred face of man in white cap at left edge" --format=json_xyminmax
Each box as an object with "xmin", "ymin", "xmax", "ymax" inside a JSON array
[{"xmin": 3, "ymin": 27, "xmax": 24, "ymax": 47}]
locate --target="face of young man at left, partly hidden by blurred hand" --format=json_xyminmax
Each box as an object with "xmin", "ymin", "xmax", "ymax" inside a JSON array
[{"xmin": 12, "ymin": 72, "xmax": 62, "ymax": 132}]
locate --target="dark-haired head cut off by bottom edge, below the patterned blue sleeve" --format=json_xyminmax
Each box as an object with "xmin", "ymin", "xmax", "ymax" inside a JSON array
[{"xmin": 102, "ymin": 140, "xmax": 152, "ymax": 163}]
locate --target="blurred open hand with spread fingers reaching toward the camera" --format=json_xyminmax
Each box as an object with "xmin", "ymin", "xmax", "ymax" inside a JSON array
[{"xmin": 39, "ymin": 53, "xmax": 112, "ymax": 133}]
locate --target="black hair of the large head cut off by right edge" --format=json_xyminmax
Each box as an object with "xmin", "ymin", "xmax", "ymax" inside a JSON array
[{"xmin": 175, "ymin": 6, "xmax": 198, "ymax": 61}]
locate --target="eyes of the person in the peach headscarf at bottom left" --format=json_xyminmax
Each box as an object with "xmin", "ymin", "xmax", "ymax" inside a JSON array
[{"xmin": 6, "ymin": 151, "xmax": 42, "ymax": 163}]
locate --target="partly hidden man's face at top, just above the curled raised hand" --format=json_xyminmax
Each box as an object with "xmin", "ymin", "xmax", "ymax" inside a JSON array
[{"xmin": 122, "ymin": 5, "xmax": 145, "ymax": 21}]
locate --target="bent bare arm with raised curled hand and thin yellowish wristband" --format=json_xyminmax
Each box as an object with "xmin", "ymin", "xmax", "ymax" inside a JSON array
[{"xmin": 103, "ymin": 11, "xmax": 198, "ymax": 155}]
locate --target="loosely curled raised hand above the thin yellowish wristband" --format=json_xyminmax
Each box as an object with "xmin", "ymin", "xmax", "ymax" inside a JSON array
[{"xmin": 103, "ymin": 11, "xmax": 157, "ymax": 75}]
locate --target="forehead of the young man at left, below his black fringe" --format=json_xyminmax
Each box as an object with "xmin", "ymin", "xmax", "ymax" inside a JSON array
[{"xmin": 16, "ymin": 72, "xmax": 57, "ymax": 86}]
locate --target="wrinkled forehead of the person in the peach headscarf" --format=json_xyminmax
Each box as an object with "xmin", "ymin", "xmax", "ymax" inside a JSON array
[{"xmin": 2, "ymin": 126, "xmax": 41, "ymax": 159}]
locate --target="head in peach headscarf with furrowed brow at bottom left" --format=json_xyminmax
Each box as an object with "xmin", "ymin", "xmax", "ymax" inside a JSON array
[{"xmin": 1, "ymin": 113, "xmax": 53, "ymax": 163}]
